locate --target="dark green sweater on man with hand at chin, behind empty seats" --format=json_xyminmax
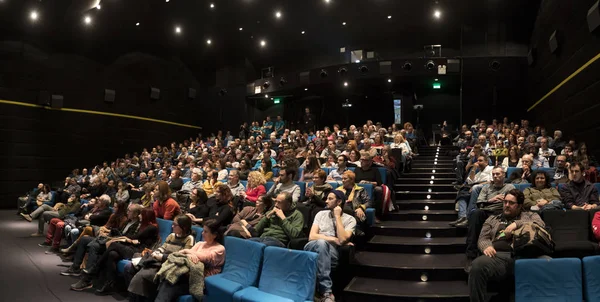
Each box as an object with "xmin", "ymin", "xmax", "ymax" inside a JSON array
[{"xmin": 254, "ymin": 209, "xmax": 304, "ymax": 245}]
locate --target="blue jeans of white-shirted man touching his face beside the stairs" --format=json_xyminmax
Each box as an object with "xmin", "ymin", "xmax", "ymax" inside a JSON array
[{"xmin": 304, "ymin": 239, "xmax": 339, "ymax": 294}]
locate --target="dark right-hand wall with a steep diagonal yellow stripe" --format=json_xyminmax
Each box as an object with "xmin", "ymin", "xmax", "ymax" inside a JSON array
[{"xmin": 528, "ymin": 0, "xmax": 600, "ymax": 150}]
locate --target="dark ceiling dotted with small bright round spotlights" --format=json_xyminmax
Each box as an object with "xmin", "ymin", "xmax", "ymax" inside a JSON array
[{"xmin": 0, "ymin": 0, "xmax": 539, "ymax": 78}]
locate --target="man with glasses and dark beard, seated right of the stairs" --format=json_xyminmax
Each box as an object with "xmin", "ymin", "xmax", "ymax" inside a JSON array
[{"xmin": 469, "ymin": 189, "xmax": 545, "ymax": 302}]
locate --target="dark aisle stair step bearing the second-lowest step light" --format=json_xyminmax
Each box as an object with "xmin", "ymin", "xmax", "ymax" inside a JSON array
[{"xmin": 366, "ymin": 235, "xmax": 466, "ymax": 254}]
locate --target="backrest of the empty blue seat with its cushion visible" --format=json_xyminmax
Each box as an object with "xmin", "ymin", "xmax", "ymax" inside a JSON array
[{"xmin": 221, "ymin": 236, "xmax": 266, "ymax": 287}]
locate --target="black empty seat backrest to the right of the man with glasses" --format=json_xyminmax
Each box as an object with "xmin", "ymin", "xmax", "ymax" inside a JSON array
[{"xmin": 542, "ymin": 210, "xmax": 591, "ymax": 242}]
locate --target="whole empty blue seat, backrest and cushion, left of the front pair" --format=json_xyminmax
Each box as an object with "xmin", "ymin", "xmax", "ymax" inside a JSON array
[{"xmin": 204, "ymin": 236, "xmax": 265, "ymax": 302}]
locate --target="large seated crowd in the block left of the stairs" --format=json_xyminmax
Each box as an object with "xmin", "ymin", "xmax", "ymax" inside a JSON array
[{"xmin": 19, "ymin": 110, "xmax": 417, "ymax": 301}]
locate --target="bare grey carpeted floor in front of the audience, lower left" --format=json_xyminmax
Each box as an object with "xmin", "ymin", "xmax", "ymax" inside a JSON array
[{"xmin": 0, "ymin": 210, "xmax": 127, "ymax": 302}]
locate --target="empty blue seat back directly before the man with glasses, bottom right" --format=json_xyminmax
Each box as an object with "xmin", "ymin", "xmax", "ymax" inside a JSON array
[{"xmin": 515, "ymin": 258, "xmax": 583, "ymax": 302}]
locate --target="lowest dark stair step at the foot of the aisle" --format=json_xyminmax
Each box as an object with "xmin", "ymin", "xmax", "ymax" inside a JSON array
[{"xmin": 344, "ymin": 277, "xmax": 469, "ymax": 302}]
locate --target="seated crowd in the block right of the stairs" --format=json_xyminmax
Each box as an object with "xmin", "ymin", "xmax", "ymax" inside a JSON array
[{"xmin": 450, "ymin": 118, "xmax": 599, "ymax": 301}]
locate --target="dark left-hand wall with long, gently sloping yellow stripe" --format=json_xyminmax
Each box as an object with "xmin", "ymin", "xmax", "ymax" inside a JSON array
[{"xmin": 0, "ymin": 41, "xmax": 251, "ymax": 207}]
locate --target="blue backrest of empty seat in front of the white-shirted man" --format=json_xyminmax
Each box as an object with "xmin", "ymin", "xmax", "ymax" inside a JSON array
[{"xmin": 258, "ymin": 247, "xmax": 317, "ymax": 302}]
